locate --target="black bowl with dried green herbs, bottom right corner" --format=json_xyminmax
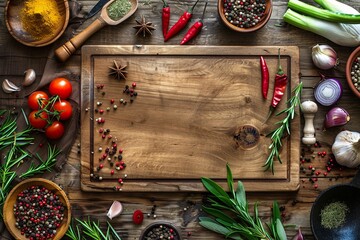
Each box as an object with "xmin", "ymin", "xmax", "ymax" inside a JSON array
[{"xmin": 310, "ymin": 172, "xmax": 360, "ymax": 240}]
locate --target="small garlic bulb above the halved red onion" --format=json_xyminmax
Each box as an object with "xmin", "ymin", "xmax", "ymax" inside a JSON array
[{"xmin": 311, "ymin": 44, "xmax": 339, "ymax": 70}]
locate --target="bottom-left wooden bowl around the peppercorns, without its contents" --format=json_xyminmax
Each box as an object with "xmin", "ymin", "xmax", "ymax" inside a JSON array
[{"xmin": 3, "ymin": 178, "xmax": 71, "ymax": 240}]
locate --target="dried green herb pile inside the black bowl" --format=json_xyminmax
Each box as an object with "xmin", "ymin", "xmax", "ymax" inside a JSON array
[{"xmin": 320, "ymin": 201, "xmax": 349, "ymax": 229}]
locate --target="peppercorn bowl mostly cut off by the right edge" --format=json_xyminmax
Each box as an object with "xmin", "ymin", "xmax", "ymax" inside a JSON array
[{"xmin": 345, "ymin": 47, "xmax": 360, "ymax": 98}]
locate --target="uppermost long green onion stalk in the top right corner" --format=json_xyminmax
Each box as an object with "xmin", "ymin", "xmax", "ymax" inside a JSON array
[{"xmin": 288, "ymin": 0, "xmax": 360, "ymax": 24}]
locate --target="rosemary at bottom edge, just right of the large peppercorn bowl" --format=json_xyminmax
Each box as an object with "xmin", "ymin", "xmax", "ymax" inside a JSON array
[{"xmin": 66, "ymin": 218, "xmax": 121, "ymax": 240}]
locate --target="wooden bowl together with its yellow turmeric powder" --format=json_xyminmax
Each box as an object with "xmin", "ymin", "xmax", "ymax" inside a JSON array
[{"xmin": 5, "ymin": 0, "xmax": 70, "ymax": 47}]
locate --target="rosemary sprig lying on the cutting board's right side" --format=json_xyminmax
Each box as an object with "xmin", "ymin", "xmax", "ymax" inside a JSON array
[{"xmin": 263, "ymin": 82, "xmax": 303, "ymax": 174}]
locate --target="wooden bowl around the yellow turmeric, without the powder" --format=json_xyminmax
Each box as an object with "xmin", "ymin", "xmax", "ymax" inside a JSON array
[{"xmin": 5, "ymin": 0, "xmax": 70, "ymax": 47}]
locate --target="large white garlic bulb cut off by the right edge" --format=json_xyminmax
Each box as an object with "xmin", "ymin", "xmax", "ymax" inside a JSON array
[{"xmin": 332, "ymin": 130, "xmax": 360, "ymax": 168}]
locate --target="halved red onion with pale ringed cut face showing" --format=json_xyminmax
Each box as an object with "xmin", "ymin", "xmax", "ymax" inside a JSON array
[{"xmin": 314, "ymin": 78, "xmax": 342, "ymax": 106}]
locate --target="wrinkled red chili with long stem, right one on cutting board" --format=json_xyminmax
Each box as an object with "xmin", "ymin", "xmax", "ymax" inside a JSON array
[{"xmin": 266, "ymin": 48, "xmax": 288, "ymax": 120}]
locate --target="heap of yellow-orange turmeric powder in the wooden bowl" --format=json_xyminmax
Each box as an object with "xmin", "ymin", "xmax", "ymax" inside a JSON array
[{"xmin": 20, "ymin": 0, "xmax": 62, "ymax": 40}]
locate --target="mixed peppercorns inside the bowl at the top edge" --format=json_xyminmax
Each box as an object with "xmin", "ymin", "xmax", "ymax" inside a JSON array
[{"xmin": 224, "ymin": 0, "xmax": 266, "ymax": 28}]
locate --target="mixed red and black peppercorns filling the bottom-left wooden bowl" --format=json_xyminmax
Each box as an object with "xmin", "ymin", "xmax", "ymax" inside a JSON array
[{"xmin": 14, "ymin": 186, "xmax": 65, "ymax": 240}]
